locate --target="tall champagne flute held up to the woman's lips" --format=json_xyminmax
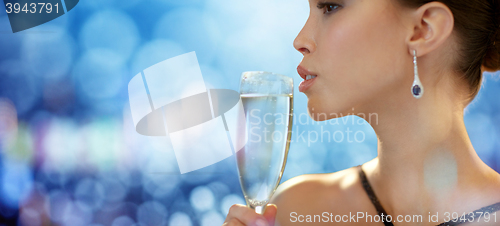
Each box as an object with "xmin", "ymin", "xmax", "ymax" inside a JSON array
[{"xmin": 235, "ymin": 71, "xmax": 293, "ymax": 214}]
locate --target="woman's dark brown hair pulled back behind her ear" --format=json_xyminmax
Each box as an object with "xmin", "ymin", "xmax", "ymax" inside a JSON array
[{"xmin": 396, "ymin": 0, "xmax": 500, "ymax": 102}]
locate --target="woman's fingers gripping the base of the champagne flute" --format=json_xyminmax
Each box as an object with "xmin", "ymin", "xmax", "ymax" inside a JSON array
[{"xmin": 222, "ymin": 204, "xmax": 278, "ymax": 226}]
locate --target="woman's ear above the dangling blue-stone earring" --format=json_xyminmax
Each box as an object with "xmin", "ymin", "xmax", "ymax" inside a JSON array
[{"xmin": 408, "ymin": 2, "xmax": 455, "ymax": 56}]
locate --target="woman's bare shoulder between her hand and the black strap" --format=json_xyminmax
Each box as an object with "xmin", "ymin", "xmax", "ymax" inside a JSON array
[{"xmin": 271, "ymin": 167, "xmax": 371, "ymax": 225}]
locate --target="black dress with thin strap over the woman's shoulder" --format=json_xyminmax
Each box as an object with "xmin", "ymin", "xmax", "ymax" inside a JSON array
[{"xmin": 357, "ymin": 165, "xmax": 500, "ymax": 226}]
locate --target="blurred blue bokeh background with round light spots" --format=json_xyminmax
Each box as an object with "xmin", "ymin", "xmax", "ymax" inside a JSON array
[{"xmin": 0, "ymin": 0, "xmax": 500, "ymax": 226}]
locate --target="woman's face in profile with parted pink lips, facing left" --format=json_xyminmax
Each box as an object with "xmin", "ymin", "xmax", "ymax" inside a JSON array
[{"xmin": 294, "ymin": 0, "xmax": 413, "ymax": 121}]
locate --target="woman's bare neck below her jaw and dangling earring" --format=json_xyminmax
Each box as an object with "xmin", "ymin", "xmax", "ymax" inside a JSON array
[{"xmin": 365, "ymin": 72, "xmax": 500, "ymax": 217}]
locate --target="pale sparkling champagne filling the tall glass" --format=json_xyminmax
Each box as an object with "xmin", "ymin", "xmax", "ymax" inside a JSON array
[{"xmin": 236, "ymin": 94, "xmax": 293, "ymax": 209}]
